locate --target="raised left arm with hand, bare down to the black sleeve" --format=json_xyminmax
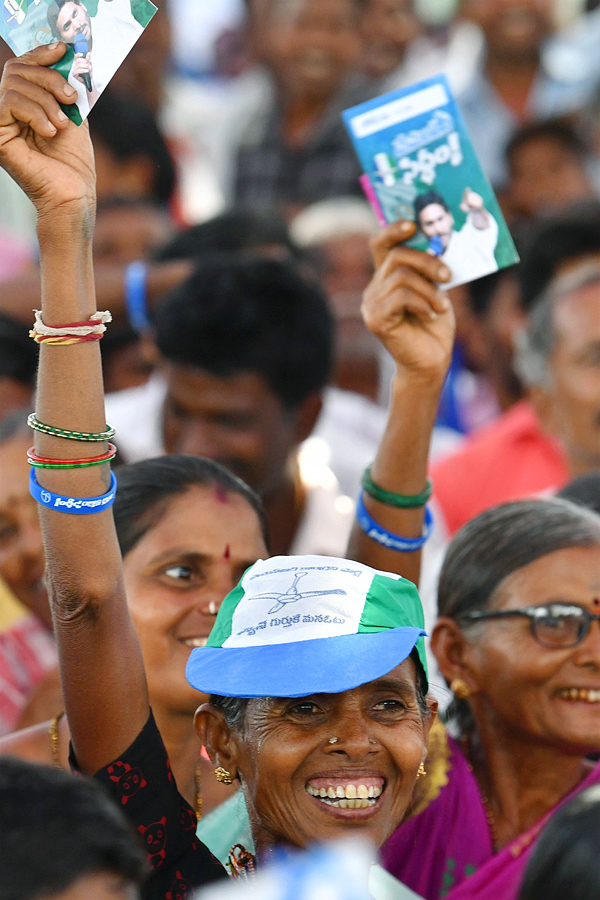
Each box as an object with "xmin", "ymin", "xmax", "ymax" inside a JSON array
[{"xmin": 0, "ymin": 44, "xmax": 148, "ymax": 772}]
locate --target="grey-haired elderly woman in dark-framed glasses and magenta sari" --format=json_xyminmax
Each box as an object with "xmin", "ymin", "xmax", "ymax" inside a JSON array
[{"xmin": 376, "ymin": 499, "xmax": 600, "ymax": 900}]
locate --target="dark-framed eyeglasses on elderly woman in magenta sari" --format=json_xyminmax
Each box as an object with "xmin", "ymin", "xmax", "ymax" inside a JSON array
[{"xmin": 459, "ymin": 603, "xmax": 600, "ymax": 648}]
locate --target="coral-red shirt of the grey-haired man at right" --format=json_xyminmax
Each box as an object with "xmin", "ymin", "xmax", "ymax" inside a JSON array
[{"xmin": 431, "ymin": 400, "xmax": 570, "ymax": 537}]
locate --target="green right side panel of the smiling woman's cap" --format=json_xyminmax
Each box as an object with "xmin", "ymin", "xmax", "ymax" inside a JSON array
[{"xmin": 358, "ymin": 574, "xmax": 429, "ymax": 681}]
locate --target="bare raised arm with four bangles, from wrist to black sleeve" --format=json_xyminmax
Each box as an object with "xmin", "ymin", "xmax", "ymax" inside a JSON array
[{"xmin": 35, "ymin": 209, "xmax": 148, "ymax": 771}]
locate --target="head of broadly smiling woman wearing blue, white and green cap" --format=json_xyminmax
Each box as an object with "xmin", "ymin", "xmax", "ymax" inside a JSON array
[{"xmin": 187, "ymin": 556, "xmax": 435, "ymax": 868}]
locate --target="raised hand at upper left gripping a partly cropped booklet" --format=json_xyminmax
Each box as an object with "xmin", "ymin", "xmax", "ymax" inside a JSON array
[{"xmin": 0, "ymin": 43, "xmax": 96, "ymax": 224}]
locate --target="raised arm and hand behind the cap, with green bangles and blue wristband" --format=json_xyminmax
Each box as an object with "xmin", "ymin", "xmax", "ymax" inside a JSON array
[{"xmin": 348, "ymin": 222, "xmax": 455, "ymax": 583}]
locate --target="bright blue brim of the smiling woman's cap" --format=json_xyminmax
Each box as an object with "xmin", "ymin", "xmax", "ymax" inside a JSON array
[{"xmin": 186, "ymin": 626, "xmax": 426, "ymax": 697}]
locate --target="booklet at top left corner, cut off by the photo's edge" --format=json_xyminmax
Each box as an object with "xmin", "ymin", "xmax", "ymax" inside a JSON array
[{"xmin": 0, "ymin": 0, "xmax": 156, "ymax": 125}]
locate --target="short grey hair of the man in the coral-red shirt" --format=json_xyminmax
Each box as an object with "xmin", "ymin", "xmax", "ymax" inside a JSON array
[{"xmin": 514, "ymin": 262, "xmax": 600, "ymax": 387}]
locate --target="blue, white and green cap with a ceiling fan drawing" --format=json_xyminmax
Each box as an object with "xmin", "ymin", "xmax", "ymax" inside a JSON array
[{"xmin": 186, "ymin": 556, "xmax": 427, "ymax": 697}]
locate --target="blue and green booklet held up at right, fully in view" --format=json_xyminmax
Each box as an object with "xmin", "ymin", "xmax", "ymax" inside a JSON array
[{"xmin": 343, "ymin": 75, "xmax": 519, "ymax": 287}]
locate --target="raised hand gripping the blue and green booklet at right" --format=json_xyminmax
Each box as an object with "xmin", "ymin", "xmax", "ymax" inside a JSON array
[{"xmin": 362, "ymin": 221, "xmax": 455, "ymax": 381}]
